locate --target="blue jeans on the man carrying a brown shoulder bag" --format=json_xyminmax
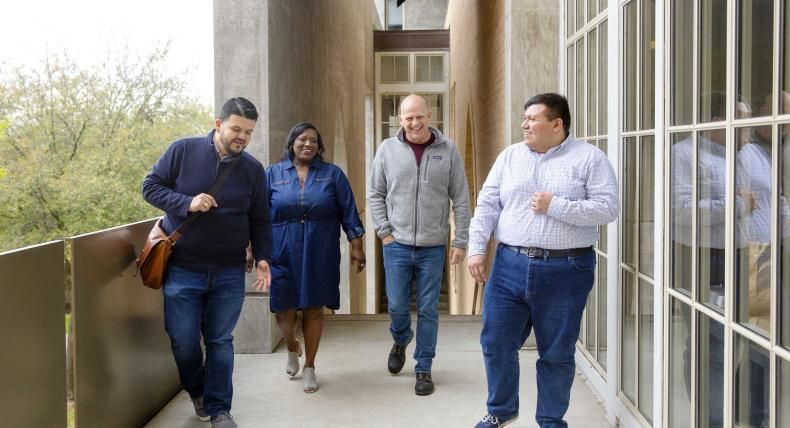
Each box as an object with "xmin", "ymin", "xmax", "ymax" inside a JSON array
[{"xmin": 162, "ymin": 264, "xmax": 244, "ymax": 416}]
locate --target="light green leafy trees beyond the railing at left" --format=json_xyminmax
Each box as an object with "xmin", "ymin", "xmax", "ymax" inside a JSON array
[{"xmin": 0, "ymin": 49, "xmax": 212, "ymax": 252}]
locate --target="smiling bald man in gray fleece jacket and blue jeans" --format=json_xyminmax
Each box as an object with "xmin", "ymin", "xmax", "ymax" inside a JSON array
[{"xmin": 368, "ymin": 95, "xmax": 471, "ymax": 395}]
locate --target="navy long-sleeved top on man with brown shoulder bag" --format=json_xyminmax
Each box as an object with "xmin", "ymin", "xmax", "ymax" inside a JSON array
[{"xmin": 143, "ymin": 131, "xmax": 272, "ymax": 269}]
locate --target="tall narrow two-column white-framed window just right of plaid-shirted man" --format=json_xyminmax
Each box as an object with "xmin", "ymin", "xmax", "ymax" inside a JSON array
[{"xmin": 619, "ymin": 0, "xmax": 656, "ymax": 423}]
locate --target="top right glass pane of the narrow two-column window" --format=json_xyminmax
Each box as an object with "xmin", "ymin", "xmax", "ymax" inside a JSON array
[{"xmin": 639, "ymin": 0, "xmax": 656, "ymax": 129}]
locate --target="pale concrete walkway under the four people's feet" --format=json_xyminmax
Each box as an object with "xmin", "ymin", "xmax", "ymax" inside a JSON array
[{"xmin": 147, "ymin": 316, "xmax": 610, "ymax": 428}]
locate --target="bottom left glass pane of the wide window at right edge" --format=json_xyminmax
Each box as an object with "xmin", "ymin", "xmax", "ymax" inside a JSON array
[{"xmin": 667, "ymin": 299, "xmax": 691, "ymax": 427}]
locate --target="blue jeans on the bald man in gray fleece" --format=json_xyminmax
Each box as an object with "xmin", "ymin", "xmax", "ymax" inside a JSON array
[{"xmin": 383, "ymin": 242, "xmax": 445, "ymax": 373}]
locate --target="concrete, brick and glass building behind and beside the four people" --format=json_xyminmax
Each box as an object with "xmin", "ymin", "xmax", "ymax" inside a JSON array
[{"xmin": 214, "ymin": 0, "xmax": 790, "ymax": 427}]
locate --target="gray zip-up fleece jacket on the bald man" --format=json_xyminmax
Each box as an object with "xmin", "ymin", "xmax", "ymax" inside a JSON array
[{"xmin": 368, "ymin": 128, "xmax": 471, "ymax": 249}]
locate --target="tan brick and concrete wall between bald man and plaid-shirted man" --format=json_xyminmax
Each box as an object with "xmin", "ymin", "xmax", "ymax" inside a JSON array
[{"xmin": 447, "ymin": 0, "xmax": 560, "ymax": 314}]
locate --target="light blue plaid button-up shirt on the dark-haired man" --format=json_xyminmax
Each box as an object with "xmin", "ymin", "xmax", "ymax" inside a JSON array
[{"xmin": 469, "ymin": 135, "xmax": 620, "ymax": 256}]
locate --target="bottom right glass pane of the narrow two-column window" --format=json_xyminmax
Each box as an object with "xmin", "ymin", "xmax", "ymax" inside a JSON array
[{"xmin": 638, "ymin": 279, "xmax": 653, "ymax": 423}]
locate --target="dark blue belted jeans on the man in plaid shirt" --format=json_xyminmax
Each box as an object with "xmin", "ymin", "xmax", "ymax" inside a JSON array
[{"xmin": 480, "ymin": 245, "xmax": 595, "ymax": 428}]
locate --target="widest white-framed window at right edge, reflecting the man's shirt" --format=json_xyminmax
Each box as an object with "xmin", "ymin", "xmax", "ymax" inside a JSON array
[{"xmin": 664, "ymin": 0, "xmax": 790, "ymax": 427}]
